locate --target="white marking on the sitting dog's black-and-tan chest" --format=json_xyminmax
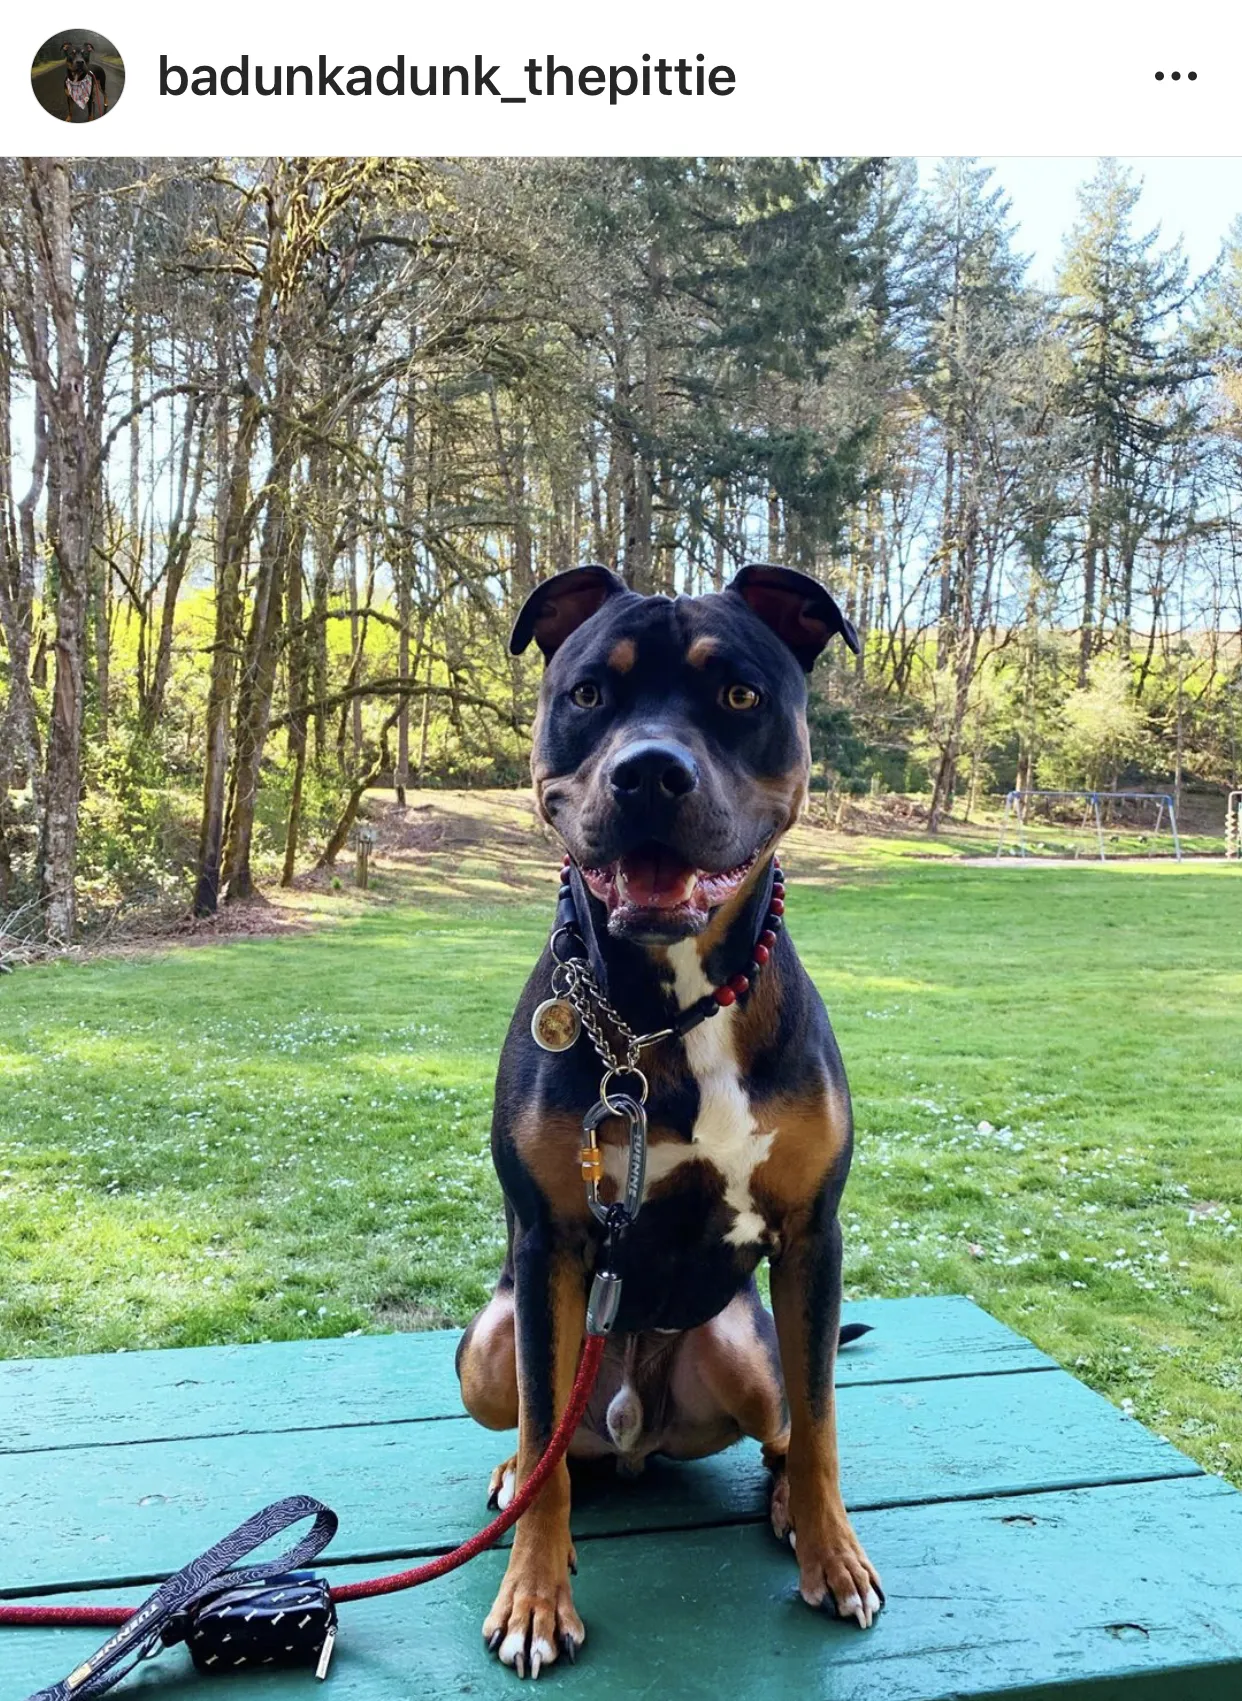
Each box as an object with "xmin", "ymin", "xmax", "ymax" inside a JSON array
[{"xmin": 604, "ymin": 939, "xmax": 776, "ymax": 1247}]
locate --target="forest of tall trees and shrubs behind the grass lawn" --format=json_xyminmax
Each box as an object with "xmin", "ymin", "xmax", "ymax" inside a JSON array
[{"xmin": 0, "ymin": 158, "xmax": 1242, "ymax": 942}]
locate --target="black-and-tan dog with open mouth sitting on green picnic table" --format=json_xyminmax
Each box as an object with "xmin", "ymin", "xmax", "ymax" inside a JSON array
[{"xmin": 458, "ymin": 566, "xmax": 883, "ymax": 1677}]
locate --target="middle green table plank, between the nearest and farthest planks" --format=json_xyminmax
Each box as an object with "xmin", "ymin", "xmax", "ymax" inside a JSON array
[{"xmin": 0, "ymin": 1371, "xmax": 1199, "ymax": 1590}]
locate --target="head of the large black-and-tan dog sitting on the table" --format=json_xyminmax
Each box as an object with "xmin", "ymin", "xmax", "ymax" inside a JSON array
[{"xmin": 509, "ymin": 566, "xmax": 857, "ymax": 942}]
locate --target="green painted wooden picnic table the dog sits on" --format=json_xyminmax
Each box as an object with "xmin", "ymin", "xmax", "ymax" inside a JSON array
[{"xmin": 0, "ymin": 1298, "xmax": 1242, "ymax": 1701}]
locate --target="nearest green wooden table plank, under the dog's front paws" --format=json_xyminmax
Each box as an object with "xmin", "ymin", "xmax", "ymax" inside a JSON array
[{"xmin": 0, "ymin": 1476, "xmax": 1242, "ymax": 1701}]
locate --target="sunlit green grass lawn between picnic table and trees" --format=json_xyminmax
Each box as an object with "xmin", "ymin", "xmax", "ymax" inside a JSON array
[{"xmin": 0, "ymin": 803, "xmax": 1242, "ymax": 1483}]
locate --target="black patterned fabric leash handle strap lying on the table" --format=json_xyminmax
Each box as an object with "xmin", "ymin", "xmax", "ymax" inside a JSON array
[{"xmin": 29, "ymin": 1493, "xmax": 337, "ymax": 1701}]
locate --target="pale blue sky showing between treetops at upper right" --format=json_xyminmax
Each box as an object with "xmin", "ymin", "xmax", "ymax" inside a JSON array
[{"xmin": 919, "ymin": 155, "xmax": 1242, "ymax": 287}]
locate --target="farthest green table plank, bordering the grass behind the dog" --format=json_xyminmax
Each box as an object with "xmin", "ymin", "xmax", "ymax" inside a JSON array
[{"xmin": 0, "ymin": 1294, "xmax": 1055, "ymax": 1453}]
